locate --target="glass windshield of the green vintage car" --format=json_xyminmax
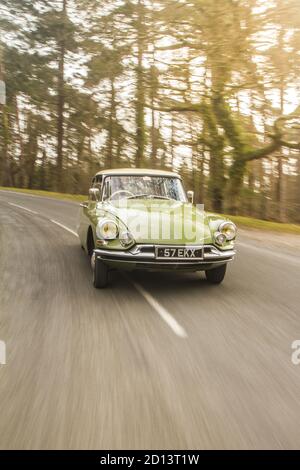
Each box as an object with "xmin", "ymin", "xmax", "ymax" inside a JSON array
[{"xmin": 103, "ymin": 175, "xmax": 187, "ymax": 202}]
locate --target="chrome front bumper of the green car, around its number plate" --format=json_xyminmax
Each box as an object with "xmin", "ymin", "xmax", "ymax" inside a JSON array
[{"xmin": 94, "ymin": 245, "xmax": 236, "ymax": 271}]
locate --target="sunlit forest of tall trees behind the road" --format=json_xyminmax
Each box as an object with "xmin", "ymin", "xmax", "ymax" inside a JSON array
[{"xmin": 0, "ymin": 0, "xmax": 300, "ymax": 223}]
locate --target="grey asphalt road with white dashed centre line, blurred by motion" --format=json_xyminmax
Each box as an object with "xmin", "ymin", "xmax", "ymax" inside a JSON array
[{"xmin": 0, "ymin": 192, "xmax": 300, "ymax": 449}]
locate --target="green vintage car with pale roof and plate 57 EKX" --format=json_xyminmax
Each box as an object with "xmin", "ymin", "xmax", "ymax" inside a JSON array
[{"xmin": 78, "ymin": 169, "xmax": 236, "ymax": 288}]
